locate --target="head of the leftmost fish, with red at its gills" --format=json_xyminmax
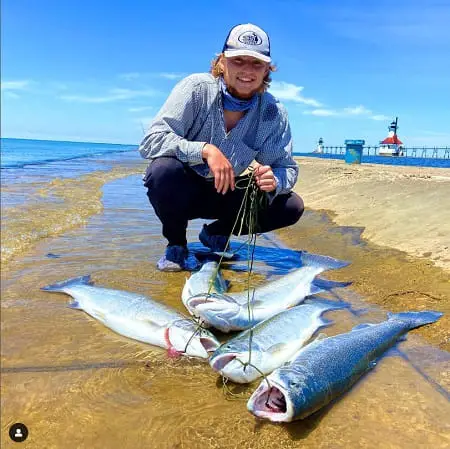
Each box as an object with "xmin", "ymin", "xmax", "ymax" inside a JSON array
[{"xmin": 168, "ymin": 319, "xmax": 220, "ymax": 359}]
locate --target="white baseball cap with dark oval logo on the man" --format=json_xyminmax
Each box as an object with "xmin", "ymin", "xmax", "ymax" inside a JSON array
[{"xmin": 222, "ymin": 23, "xmax": 272, "ymax": 62}]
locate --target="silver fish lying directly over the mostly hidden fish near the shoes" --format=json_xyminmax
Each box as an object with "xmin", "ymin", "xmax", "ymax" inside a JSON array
[{"xmin": 187, "ymin": 254, "xmax": 348, "ymax": 332}]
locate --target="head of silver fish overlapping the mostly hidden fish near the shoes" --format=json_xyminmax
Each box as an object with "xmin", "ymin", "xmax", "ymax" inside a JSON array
[{"xmin": 187, "ymin": 293, "xmax": 241, "ymax": 332}]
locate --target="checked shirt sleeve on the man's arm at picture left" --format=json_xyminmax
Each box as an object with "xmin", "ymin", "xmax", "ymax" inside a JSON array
[{"xmin": 139, "ymin": 76, "xmax": 206, "ymax": 165}]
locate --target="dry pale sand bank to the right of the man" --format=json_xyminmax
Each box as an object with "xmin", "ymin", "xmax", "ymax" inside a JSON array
[{"xmin": 294, "ymin": 156, "xmax": 450, "ymax": 271}]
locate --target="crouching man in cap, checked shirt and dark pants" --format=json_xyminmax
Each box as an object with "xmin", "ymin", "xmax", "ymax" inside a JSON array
[{"xmin": 139, "ymin": 24, "xmax": 304, "ymax": 271}]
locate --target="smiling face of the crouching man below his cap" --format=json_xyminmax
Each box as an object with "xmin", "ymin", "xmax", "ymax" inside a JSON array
[{"xmin": 221, "ymin": 56, "xmax": 269, "ymax": 99}]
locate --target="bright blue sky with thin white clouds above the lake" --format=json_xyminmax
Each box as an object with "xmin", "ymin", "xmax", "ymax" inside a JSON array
[{"xmin": 1, "ymin": 0, "xmax": 450, "ymax": 152}]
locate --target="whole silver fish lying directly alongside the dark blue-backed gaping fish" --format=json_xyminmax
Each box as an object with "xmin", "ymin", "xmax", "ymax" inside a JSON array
[{"xmin": 209, "ymin": 299, "xmax": 348, "ymax": 383}]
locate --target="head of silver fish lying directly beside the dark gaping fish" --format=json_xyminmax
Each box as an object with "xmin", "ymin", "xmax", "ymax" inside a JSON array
[{"xmin": 209, "ymin": 342, "xmax": 262, "ymax": 383}]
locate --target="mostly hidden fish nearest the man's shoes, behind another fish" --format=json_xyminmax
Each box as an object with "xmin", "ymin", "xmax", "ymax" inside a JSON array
[{"xmin": 181, "ymin": 261, "xmax": 228, "ymax": 315}]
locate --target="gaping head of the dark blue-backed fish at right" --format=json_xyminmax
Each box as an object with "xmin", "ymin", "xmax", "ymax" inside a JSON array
[{"xmin": 247, "ymin": 364, "xmax": 315, "ymax": 422}]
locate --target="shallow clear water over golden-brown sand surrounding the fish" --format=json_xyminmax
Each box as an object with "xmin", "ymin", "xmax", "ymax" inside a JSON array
[{"xmin": 1, "ymin": 172, "xmax": 450, "ymax": 448}]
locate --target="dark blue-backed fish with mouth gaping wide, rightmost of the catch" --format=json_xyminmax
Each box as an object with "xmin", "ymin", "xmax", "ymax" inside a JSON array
[{"xmin": 247, "ymin": 311, "xmax": 443, "ymax": 422}]
